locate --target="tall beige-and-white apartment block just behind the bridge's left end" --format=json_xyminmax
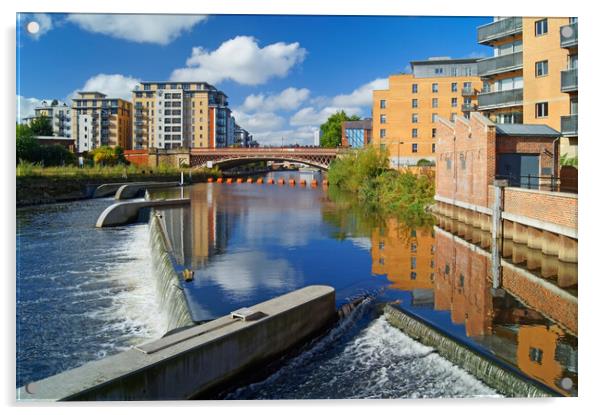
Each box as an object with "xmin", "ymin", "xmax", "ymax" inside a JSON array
[{"xmin": 133, "ymin": 82, "xmax": 234, "ymax": 149}]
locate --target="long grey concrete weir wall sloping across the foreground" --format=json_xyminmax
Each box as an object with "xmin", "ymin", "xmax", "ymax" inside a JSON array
[{"xmin": 17, "ymin": 285, "xmax": 336, "ymax": 401}]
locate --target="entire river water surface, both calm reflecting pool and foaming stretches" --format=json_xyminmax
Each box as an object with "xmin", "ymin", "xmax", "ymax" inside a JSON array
[{"xmin": 17, "ymin": 173, "xmax": 577, "ymax": 399}]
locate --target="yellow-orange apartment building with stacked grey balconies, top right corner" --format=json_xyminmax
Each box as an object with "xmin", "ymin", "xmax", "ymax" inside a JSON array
[{"xmin": 477, "ymin": 17, "xmax": 578, "ymax": 156}]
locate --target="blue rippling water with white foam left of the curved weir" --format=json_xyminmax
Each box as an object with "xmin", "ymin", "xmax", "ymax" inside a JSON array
[{"xmin": 17, "ymin": 199, "xmax": 167, "ymax": 386}]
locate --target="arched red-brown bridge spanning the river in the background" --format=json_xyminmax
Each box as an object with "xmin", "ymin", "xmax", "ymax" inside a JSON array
[{"xmin": 190, "ymin": 147, "xmax": 344, "ymax": 170}]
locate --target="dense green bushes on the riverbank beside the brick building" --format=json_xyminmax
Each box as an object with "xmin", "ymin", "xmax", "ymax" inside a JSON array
[{"xmin": 328, "ymin": 146, "xmax": 435, "ymax": 223}]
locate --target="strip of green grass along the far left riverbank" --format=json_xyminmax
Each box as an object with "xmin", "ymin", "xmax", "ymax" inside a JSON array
[{"xmin": 16, "ymin": 162, "xmax": 221, "ymax": 180}]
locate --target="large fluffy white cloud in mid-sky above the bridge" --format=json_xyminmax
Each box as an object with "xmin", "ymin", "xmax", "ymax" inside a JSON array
[{"xmin": 171, "ymin": 36, "xmax": 306, "ymax": 85}]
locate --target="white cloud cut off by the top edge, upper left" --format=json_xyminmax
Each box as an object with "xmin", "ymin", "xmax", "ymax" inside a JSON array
[{"xmin": 67, "ymin": 14, "xmax": 207, "ymax": 45}]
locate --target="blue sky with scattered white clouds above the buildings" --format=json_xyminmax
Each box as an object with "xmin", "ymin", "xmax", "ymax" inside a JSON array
[{"xmin": 17, "ymin": 13, "xmax": 492, "ymax": 145}]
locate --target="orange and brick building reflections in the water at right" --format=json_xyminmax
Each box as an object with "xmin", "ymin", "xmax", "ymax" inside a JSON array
[{"xmin": 371, "ymin": 219, "xmax": 577, "ymax": 395}]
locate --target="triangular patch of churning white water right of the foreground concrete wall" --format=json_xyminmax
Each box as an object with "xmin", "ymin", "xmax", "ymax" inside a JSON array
[{"xmin": 226, "ymin": 302, "xmax": 501, "ymax": 399}]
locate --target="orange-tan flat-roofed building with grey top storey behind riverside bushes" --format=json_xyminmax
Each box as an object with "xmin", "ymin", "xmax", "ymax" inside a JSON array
[{"xmin": 372, "ymin": 57, "xmax": 482, "ymax": 167}]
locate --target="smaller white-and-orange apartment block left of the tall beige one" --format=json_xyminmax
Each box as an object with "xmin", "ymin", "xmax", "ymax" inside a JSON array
[{"xmin": 71, "ymin": 91, "xmax": 132, "ymax": 153}]
